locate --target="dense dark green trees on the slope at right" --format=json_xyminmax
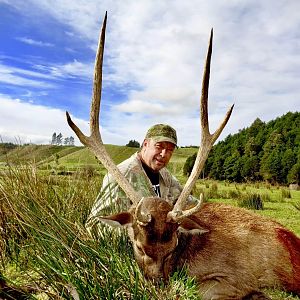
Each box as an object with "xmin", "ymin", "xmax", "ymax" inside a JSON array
[{"xmin": 183, "ymin": 112, "xmax": 300, "ymax": 184}]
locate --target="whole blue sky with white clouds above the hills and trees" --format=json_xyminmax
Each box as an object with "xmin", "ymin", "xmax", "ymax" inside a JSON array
[{"xmin": 0, "ymin": 0, "xmax": 300, "ymax": 146}]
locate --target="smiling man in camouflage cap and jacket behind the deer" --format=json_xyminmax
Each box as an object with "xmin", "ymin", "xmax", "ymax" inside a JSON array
[{"xmin": 86, "ymin": 124, "xmax": 196, "ymax": 230}]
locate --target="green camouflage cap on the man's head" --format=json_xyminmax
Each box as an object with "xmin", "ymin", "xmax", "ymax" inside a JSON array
[{"xmin": 145, "ymin": 124, "xmax": 177, "ymax": 145}]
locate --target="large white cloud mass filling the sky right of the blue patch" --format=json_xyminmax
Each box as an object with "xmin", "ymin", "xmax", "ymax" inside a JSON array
[{"xmin": 0, "ymin": 0, "xmax": 300, "ymax": 145}]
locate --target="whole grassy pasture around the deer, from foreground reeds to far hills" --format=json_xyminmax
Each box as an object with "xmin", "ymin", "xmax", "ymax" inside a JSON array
[{"xmin": 0, "ymin": 145, "xmax": 300, "ymax": 300}]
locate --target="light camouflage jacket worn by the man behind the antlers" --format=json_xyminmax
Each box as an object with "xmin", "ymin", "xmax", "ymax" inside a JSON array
[{"xmin": 86, "ymin": 152, "xmax": 196, "ymax": 229}]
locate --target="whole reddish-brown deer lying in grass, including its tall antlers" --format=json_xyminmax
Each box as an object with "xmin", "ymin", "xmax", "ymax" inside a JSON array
[{"xmin": 66, "ymin": 13, "xmax": 300, "ymax": 300}]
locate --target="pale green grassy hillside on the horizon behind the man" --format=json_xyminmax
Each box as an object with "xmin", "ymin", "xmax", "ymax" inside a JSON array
[{"xmin": 0, "ymin": 144, "xmax": 197, "ymax": 177}]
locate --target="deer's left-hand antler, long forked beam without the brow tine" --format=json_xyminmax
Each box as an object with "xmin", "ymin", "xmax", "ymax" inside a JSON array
[{"xmin": 66, "ymin": 12, "xmax": 140, "ymax": 204}]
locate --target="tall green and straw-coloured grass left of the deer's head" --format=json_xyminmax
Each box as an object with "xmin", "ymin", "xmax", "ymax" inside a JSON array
[{"xmin": 0, "ymin": 165, "xmax": 199, "ymax": 299}]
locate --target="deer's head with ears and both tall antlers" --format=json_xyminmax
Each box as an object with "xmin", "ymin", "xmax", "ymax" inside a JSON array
[{"xmin": 66, "ymin": 14, "xmax": 233, "ymax": 278}]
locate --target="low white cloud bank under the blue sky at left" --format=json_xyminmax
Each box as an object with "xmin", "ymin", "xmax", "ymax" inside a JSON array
[{"xmin": 0, "ymin": 94, "xmax": 129, "ymax": 145}]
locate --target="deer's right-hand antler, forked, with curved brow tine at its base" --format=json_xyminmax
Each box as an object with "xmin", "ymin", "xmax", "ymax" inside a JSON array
[{"xmin": 168, "ymin": 30, "xmax": 234, "ymax": 222}]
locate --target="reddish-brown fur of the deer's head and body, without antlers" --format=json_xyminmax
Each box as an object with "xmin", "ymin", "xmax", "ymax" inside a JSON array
[{"xmin": 103, "ymin": 198, "xmax": 300, "ymax": 299}]
